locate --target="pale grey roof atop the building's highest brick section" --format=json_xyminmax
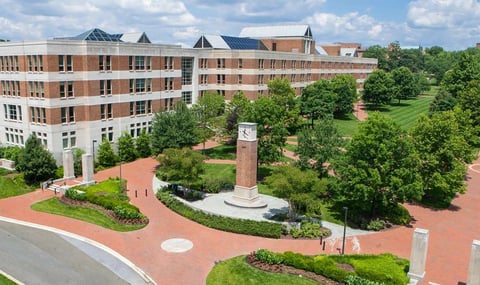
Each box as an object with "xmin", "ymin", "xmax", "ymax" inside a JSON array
[{"xmin": 240, "ymin": 25, "xmax": 312, "ymax": 38}]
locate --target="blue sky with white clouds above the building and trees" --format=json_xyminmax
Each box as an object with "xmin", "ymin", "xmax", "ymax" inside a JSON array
[{"xmin": 0, "ymin": 0, "xmax": 480, "ymax": 50}]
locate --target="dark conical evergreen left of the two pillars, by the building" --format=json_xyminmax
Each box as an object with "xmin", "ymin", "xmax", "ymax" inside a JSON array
[{"xmin": 17, "ymin": 135, "xmax": 57, "ymax": 184}]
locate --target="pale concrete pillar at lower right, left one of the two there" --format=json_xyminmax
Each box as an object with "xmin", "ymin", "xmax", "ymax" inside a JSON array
[{"xmin": 408, "ymin": 229, "xmax": 428, "ymax": 284}]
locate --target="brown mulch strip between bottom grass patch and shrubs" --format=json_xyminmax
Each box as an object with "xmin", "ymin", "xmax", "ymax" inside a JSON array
[{"xmin": 247, "ymin": 252, "xmax": 345, "ymax": 285}]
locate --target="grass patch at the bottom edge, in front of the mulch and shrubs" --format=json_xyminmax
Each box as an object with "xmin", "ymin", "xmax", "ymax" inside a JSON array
[{"xmin": 207, "ymin": 256, "xmax": 318, "ymax": 285}]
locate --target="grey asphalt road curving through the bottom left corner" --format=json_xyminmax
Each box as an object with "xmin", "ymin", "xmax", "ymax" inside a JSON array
[{"xmin": 0, "ymin": 221, "xmax": 135, "ymax": 285}]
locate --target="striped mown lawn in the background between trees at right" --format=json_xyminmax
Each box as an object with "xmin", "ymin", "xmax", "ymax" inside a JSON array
[{"xmin": 368, "ymin": 96, "xmax": 434, "ymax": 130}]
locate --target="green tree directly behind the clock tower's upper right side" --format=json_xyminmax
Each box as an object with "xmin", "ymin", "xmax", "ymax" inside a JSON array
[{"xmin": 242, "ymin": 96, "xmax": 288, "ymax": 163}]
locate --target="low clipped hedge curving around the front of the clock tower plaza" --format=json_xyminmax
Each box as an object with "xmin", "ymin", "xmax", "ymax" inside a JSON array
[{"xmin": 157, "ymin": 191, "xmax": 283, "ymax": 238}]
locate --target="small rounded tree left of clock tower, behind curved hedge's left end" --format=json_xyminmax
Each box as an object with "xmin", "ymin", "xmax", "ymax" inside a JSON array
[{"xmin": 158, "ymin": 148, "xmax": 205, "ymax": 189}]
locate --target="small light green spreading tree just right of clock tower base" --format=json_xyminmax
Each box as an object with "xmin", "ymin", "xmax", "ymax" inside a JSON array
[{"xmin": 265, "ymin": 166, "xmax": 327, "ymax": 216}]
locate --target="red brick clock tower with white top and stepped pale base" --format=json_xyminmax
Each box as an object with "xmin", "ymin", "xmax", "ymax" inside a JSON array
[{"xmin": 225, "ymin": 123, "xmax": 267, "ymax": 208}]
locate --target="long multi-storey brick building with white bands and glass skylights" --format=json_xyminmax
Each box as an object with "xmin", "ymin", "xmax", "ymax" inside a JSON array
[{"xmin": 0, "ymin": 26, "xmax": 377, "ymax": 161}]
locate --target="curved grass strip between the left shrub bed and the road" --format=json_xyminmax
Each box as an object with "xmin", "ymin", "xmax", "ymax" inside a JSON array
[{"xmin": 31, "ymin": 197, "xmax": 146, "ymax": 232}]
